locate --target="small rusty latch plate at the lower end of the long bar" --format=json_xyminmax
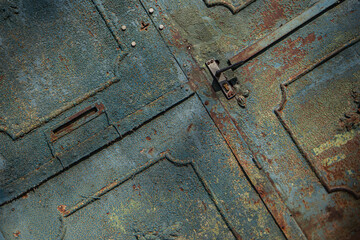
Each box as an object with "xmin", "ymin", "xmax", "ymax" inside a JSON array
[{"xmin": 206, "ymin": 59, "xmax": 236, "ymax": 99}]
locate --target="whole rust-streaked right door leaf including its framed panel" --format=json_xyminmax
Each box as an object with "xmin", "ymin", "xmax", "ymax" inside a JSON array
[{"xmin": 140, "ymin": 0, "xmax": 360, "ymax": 239}]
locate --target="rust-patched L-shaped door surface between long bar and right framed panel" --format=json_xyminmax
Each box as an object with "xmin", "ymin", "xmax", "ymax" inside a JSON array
[{"xmin": 219, "ymin": 1, "xmax": 360, "ymax": 239}]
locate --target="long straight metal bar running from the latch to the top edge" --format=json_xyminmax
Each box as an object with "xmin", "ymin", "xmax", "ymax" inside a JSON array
[{"xmin": 214, "ymin": 0, "xmax": 341, "ymax": 79}]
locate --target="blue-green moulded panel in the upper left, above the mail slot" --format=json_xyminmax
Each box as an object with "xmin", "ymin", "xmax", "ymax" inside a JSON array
[{"xmin": 0, "ymin": 0, "xmax": 122, "ymax": 139}]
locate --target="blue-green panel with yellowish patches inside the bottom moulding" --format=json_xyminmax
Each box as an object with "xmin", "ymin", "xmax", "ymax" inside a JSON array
[{"xmin": 64, "ymin": 157, "xmax": 240, "ymax": 239}]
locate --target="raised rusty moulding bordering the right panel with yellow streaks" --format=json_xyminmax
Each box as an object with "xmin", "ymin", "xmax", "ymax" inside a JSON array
[{"xmin": 274, "ymin": 36, "xmax": 360, "ymax": 199}]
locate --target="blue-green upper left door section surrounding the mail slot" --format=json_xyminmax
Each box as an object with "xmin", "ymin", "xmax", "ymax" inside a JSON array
[{"xmin": 0, "ymin": 0, "xmax": 192, "ymax": 204}]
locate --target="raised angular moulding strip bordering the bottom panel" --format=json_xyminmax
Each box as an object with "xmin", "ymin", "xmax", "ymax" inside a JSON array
[{"xmin": 58, "ymin": 153, "xmax": 241, "ymax": 240}]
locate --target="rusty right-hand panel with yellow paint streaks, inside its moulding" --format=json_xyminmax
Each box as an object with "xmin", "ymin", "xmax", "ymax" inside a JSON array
[{"xmin": 276, "ymin": 38, "xmax": 360, "ymax": 198}]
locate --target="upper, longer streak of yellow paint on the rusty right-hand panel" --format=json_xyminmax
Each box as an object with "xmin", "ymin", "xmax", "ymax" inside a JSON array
[{"xmin": 313, "ymin": 129, "xmax": 360, "ymax": 156}]
